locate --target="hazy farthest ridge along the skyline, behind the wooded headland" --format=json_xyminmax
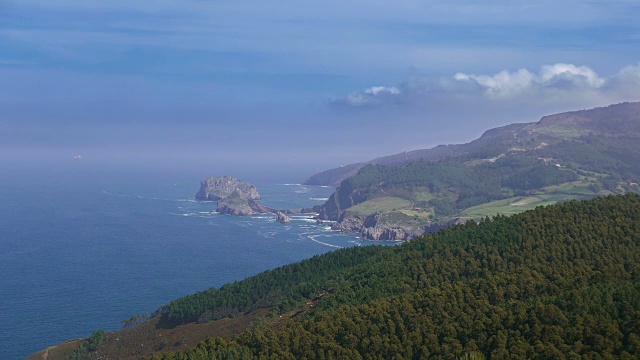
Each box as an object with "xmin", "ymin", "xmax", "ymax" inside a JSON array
[{"xmin": 305, "ymin": 102, "xmax": 640, "ymax": 187}]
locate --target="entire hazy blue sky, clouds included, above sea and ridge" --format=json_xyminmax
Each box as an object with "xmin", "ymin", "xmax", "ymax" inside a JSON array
[{"xmin": 0, "ymin": 0, "xmax": 640, "ymax": 178}]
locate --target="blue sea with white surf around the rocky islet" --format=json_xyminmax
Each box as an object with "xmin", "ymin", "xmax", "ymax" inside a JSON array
[{"xmin": 0, "ymin": 164, "xmax": 392, "ymax": 359}]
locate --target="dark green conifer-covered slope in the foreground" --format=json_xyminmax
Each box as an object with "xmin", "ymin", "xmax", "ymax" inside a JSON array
[{"xmin": 32, "ymin": 194, "xmax": 640, "ymax": 359}]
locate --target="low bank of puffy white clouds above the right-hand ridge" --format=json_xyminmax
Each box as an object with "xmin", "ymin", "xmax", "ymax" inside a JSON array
[{"xmin": 332, "ymin": 63, "xmax": 640, "ymax": 107}]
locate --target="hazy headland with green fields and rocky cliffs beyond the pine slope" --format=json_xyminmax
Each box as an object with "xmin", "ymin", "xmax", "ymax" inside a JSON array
[{"xmin": 320, "ymin": 103, "xmax": 640, "ymax": 240}]
